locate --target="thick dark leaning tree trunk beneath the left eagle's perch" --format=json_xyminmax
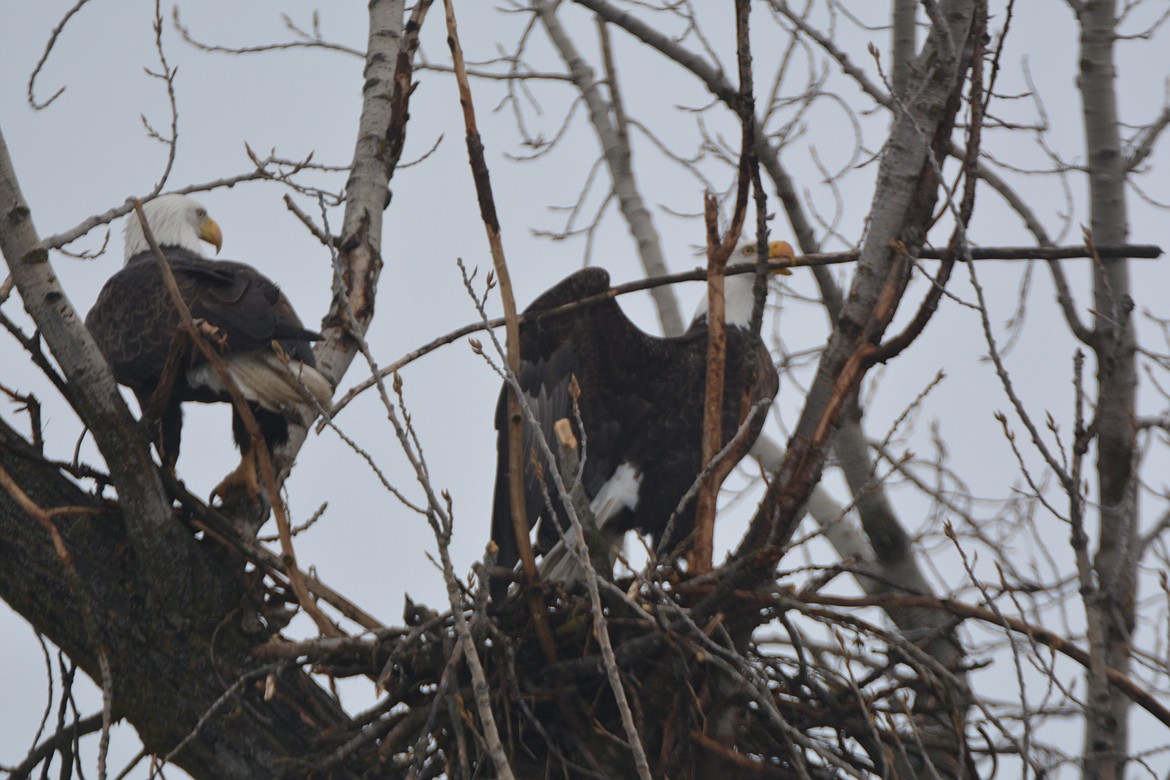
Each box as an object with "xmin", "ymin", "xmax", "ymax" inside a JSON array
[{"xmin": 0, "ymin": 421, "xmax": 362, "ymax": 778}]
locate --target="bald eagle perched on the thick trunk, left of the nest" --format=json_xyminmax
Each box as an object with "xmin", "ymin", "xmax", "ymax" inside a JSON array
[{"xmin": 85, "ymin": 195, "xmax": 332, "ymax": 498}]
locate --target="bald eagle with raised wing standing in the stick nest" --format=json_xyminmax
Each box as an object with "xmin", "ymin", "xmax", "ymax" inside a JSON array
[{"xmin": 491, "ymin": 241, "xmax": 792, "ymax": 605}]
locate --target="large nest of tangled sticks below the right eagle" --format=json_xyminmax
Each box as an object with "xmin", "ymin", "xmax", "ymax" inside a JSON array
[{"xmin": 287, "ymin": 580, "xmax": 963, "ymax": 780}]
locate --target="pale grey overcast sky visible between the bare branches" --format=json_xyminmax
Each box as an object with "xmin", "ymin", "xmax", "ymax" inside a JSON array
[{"xmin": 0, "ymin": 0, "xmax": 1170, "ymax": 776}]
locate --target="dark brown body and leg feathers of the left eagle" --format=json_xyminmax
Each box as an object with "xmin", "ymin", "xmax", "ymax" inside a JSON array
[{"xmin": 85, "ymin": 247, "xmax": 321, "ymax": 465}]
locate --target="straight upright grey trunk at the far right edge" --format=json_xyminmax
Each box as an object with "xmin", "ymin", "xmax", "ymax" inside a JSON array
[{"xmin": 1079, "ymin": 0, "xmax": 1137, "ymax": 778}]
